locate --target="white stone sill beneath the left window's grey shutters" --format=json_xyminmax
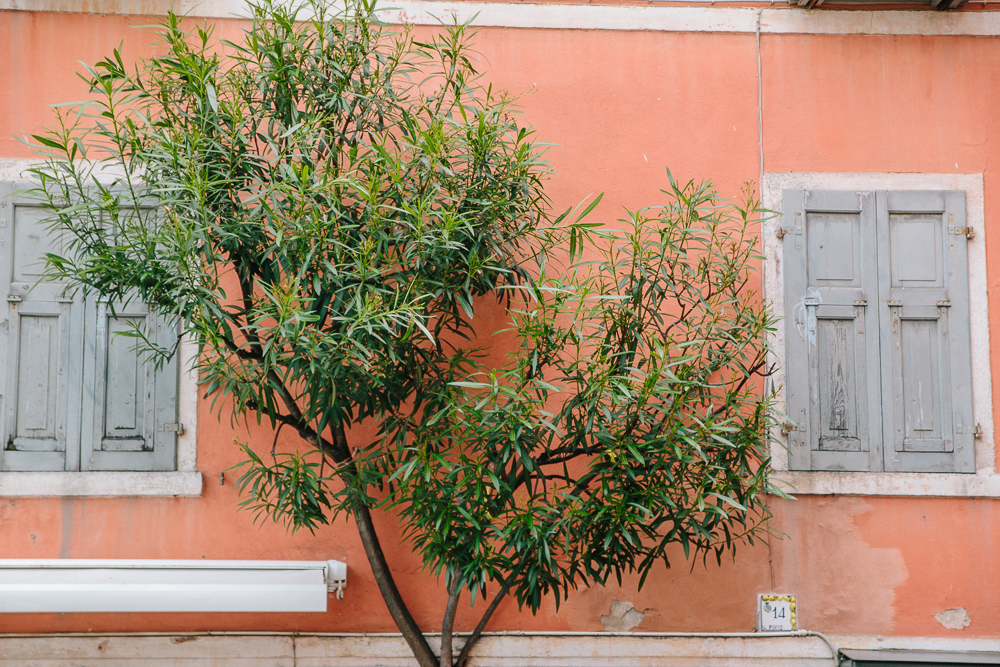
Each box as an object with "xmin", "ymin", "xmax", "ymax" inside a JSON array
[{"xmin": 0, "ymin": 471, "xmax": 202, "ymax": 498}]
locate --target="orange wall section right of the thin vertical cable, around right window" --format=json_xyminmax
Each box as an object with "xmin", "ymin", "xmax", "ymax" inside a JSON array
[{"xmin": 761, "ymin": 30, "xmax": 1000, "ymax": 636}]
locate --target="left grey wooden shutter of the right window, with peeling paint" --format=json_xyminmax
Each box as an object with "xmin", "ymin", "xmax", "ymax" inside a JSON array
[{"xmin": 783, "ymin": 190, "xmax": 881, "ymax": 471}]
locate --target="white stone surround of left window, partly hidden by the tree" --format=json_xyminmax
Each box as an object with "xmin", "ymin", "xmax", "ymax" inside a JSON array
[{"xmin": 0, "ymin": 158, "xmax": 202, "ymax": 497}]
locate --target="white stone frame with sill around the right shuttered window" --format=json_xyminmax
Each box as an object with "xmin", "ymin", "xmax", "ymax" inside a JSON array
[{"xmin": 761, "ymin": 173, "xmax": 1000, "ymax": 498}]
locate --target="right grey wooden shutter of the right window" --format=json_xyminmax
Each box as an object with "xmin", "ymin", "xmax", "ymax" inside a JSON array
[{"xmin": 878, "ymin": 192, "xmax": 975, "ymax": 472}]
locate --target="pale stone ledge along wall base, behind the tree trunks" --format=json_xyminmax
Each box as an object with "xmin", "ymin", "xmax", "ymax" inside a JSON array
[{"xmin": 0, "ymin": 633, "xmax": 832, "ymax": 667}]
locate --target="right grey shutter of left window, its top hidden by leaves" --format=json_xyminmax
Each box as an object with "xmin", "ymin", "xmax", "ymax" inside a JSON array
[{"xmin": 83, "ymin": 302, "xmax": 177, "ymax": 470}]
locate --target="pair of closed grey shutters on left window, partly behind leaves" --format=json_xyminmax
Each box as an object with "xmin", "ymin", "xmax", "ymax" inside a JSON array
[{"xmin": 0, "ymin": 183, "xmax": 178, "ymax": 471}]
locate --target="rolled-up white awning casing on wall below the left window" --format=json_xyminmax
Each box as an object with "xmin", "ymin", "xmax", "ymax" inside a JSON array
[{"xmin": 0, "ymin": 559, "xmax": 347, "ymax": 614}]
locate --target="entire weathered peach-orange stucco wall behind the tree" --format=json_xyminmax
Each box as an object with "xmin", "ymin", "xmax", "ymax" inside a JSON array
[{"xmin": 0, "ymin": 6, "xmax": 1000, "ymax": 636}]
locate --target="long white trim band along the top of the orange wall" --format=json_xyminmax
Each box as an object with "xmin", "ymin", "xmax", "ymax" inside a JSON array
[{"xmin": 0, "ymin": 0, "xmax": 1000, "ymax": 37}]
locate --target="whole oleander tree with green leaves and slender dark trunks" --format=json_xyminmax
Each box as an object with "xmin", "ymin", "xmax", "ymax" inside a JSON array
[{"xmin": 31, "ymin": 0, "xmax": 781, "ymax": 667}]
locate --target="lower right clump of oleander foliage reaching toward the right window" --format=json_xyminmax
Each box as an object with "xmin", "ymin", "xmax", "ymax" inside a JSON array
[{"xmin": 376, "ymin": 176, "xmax": 781, "ymax": 610}]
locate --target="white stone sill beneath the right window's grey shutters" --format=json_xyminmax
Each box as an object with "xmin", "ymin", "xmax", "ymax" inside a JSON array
[{"xmin": 771, "ymin": 470, "xmax": 1000, "ymax": 498}]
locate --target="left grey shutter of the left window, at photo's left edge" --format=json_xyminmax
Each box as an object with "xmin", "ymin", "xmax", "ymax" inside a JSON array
[{"xmin": 0, "ymin": 183, "xmax": 83, "ymax": 470}]
